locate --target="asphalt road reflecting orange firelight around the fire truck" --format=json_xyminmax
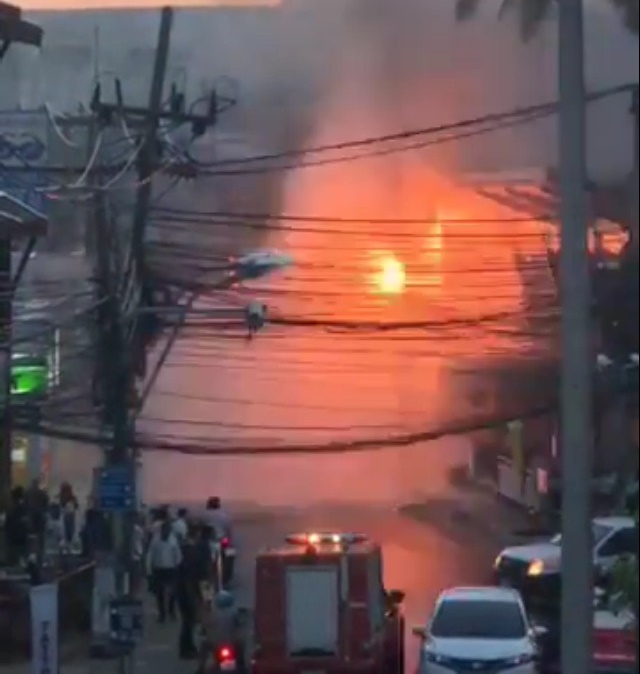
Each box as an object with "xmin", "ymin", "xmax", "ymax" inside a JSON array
[{"xmin": 116, "ymin": 498, "xmax": 493, "ymax": 674}]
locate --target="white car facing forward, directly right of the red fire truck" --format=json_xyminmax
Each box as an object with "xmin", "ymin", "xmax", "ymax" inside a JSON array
[{"xmin": 413, "ymin": 587, "xmax": 542, "ymax": 674}]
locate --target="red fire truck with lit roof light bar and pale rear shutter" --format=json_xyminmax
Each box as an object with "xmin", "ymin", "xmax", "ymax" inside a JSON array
[{"xmin": 251, "ymin": 533, "xmax": 404, "ymax": 674}]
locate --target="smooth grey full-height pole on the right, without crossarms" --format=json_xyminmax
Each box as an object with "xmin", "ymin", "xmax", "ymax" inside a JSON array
[{"xmin": 558, "ymin": 0, "xmax": 594, "ymax": 674}]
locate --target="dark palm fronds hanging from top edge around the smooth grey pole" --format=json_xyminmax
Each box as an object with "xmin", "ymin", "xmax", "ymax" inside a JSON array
[{"xmin": 456, "ymin": 0, "xmax": 638, "ymax": 42}]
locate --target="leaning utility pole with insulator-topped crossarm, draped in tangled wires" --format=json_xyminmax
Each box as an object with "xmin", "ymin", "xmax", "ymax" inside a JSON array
[{"xmin": 91, "ymin": 7, "xmax": 217, "ymax": 660}]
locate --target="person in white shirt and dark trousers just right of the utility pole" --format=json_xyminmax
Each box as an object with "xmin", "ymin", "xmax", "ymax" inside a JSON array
[{"xmin": 147, "ymin": 520, "xmax": 182, "ymax": 622}]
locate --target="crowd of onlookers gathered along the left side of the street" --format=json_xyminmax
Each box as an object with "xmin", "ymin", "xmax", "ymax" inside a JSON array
[{"xmin": 4, "ymin": 480, "xmax": 242, "ymax": 672}]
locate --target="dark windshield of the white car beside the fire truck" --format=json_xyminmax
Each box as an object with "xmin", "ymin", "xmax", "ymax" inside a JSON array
[{"xmin": 430, "ymin": 600, "xmax": 526, "ymax": 639}]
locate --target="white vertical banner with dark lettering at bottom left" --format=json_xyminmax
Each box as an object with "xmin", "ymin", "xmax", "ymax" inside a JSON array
[{"xmin": 31, "ymin": 583, "xmax": 59, "ymax": 674}]
